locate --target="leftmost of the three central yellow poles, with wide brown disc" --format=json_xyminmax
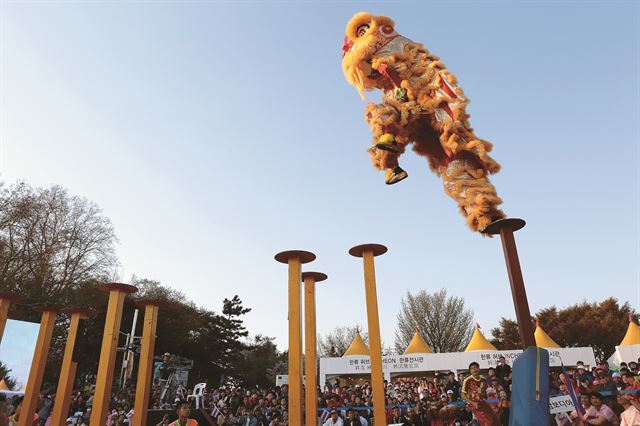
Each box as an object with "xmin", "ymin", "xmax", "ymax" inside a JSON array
[{"xmin": 275, "ymin": 250, "xmax": 316, "ymax": 425}]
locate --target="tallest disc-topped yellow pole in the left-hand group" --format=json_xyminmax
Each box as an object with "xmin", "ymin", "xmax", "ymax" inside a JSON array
[{"xmin": 89, "ymin": 283, "xmax": 138, "ymax": 426}]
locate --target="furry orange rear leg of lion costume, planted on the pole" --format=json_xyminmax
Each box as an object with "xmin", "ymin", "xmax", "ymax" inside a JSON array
[{"xmin": 442, "ymin": 154, "xmax": 505, "ymax": 231}]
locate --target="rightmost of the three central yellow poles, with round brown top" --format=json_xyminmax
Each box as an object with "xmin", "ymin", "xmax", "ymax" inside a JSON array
[{"xmin": 349, "ymin": 244, "xmax": 387, "ymax": 426}]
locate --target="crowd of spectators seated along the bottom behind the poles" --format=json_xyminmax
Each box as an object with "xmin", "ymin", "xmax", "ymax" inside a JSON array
[{"xmin": 6, "ymin": 359, "xmax": 640, "ymax": 426}]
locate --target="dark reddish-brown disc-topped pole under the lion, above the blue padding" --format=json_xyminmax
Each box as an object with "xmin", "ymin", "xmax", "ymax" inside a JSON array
[{"xmin": 482, "ymin": 218, "xmax": 536, "ymax": 349}]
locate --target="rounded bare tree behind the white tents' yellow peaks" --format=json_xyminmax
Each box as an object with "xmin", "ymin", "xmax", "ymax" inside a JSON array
[{"xmin": 395, "ymin": 289, "xmax": 473, "ymax": 353}]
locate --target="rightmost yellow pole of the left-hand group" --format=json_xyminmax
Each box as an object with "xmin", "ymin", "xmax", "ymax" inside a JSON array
[{"xmin": 132, "ymin": 301, "xmax": 158, "ymax": 426}]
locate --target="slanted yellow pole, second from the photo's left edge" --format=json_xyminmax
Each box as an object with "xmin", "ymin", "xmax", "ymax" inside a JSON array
[{"xmin": 18, "ymin": 308, "xmax": 57, "ymax": 426}]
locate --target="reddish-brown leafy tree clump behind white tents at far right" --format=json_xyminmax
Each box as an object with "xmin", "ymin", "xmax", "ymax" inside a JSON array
[{"xmin": 491, "ymin": 297, "xmax": 638, "ymax": 360}]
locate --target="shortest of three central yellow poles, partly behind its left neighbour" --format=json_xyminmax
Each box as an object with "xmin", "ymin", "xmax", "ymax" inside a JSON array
[{"xmin": 302, "ymin": 272, "xmax": 327, "ymax": 426}]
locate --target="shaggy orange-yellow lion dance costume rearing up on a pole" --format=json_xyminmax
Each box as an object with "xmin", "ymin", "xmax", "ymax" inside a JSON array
[{"xmin": 342, "ymin": 13, "xmax": 505, "ymax": 231}]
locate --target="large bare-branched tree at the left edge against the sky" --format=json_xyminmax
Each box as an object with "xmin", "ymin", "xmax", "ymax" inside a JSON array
[{"xmin": 0, "ymin": 183, "xmax": 117, "ymax": 308}]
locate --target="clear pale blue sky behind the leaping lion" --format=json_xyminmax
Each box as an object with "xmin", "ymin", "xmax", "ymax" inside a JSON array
[{"xmin": 0, "ymin": 1, "xmax": 640, "ymax": 347}]
